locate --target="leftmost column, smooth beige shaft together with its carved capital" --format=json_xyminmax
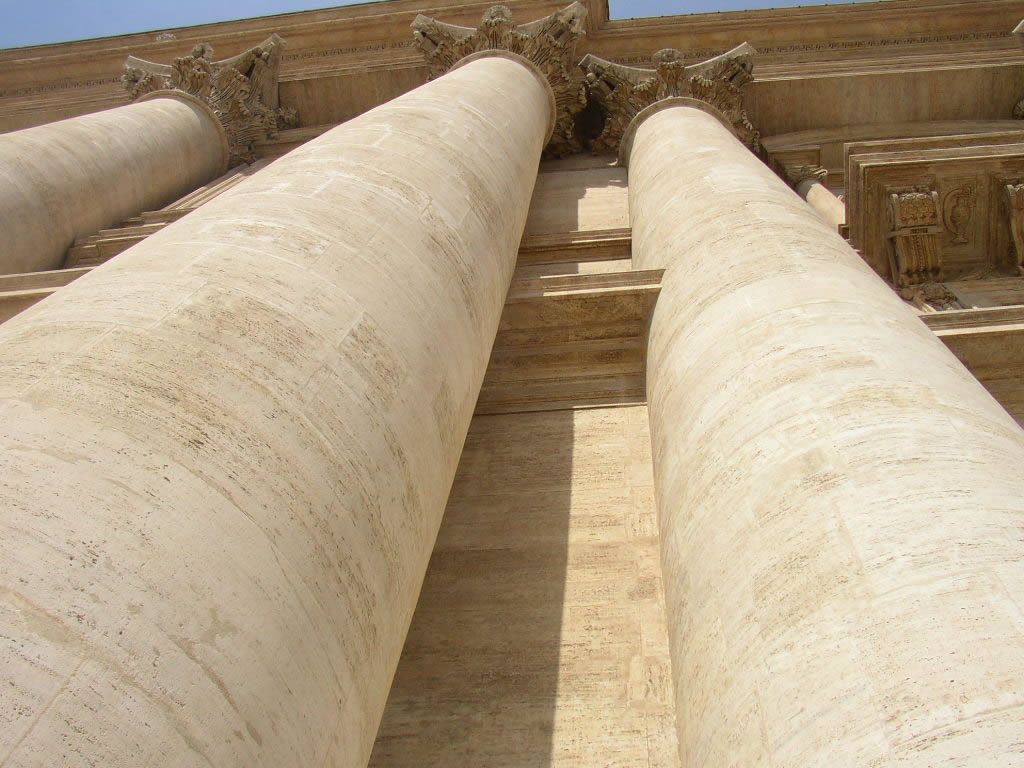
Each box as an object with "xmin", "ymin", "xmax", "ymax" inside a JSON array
[{"xmin": 0, "ymin": 35, "xmax": 294, "ymax": 274}]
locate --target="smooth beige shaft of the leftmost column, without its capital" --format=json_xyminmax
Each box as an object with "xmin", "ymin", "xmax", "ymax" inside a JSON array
[{"xmin": 0, "ymin": 97, "xmax": 227, "ymax": 274}]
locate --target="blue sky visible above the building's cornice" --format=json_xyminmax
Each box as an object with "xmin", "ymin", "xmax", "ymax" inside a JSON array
[{"xmin": 0, "ymin": 0, "xmax": 872, "ymax": 48}]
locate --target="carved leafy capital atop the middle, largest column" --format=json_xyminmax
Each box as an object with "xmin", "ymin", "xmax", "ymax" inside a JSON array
[{"xmin": 413, "ymin": 2, "xmax": 587, "ymax": 157}]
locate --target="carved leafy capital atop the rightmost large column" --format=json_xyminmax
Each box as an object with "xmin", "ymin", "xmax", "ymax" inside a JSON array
[{"xmin": 580, "ymin": 43, "xmax": 760, "ymax": 153}]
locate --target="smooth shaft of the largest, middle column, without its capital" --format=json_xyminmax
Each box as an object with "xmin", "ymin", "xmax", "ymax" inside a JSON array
[{"xmin": 0, "ymin": 56, "xmax": 550, "ymax": 768}]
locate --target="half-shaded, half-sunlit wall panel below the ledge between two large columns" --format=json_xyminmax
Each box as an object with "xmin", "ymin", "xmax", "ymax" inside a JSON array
[{"xmin": 370, "ymin": 406, "xmax": 679, "ymax": 768}]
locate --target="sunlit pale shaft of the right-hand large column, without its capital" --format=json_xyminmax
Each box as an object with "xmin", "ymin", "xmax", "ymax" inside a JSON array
[{"xmin": 629, "ymin": 106, "xmax": 1024, "ymax": 768}]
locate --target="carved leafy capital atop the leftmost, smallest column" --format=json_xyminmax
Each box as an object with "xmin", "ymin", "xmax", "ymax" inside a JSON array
[{"xmin": 121, "ymin": 35, "xmax": 298, "ymax": 163}]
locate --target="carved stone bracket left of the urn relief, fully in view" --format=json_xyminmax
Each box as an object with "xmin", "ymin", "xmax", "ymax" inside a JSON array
[{"xmin": 889, "ymin": 189, "xmax": 942, "ymax": 288}]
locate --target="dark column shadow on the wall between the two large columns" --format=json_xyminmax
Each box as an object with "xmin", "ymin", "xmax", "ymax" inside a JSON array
[{"xmin": 370, "ymin": 411, "xmax": 573, "ymax": 768}]
